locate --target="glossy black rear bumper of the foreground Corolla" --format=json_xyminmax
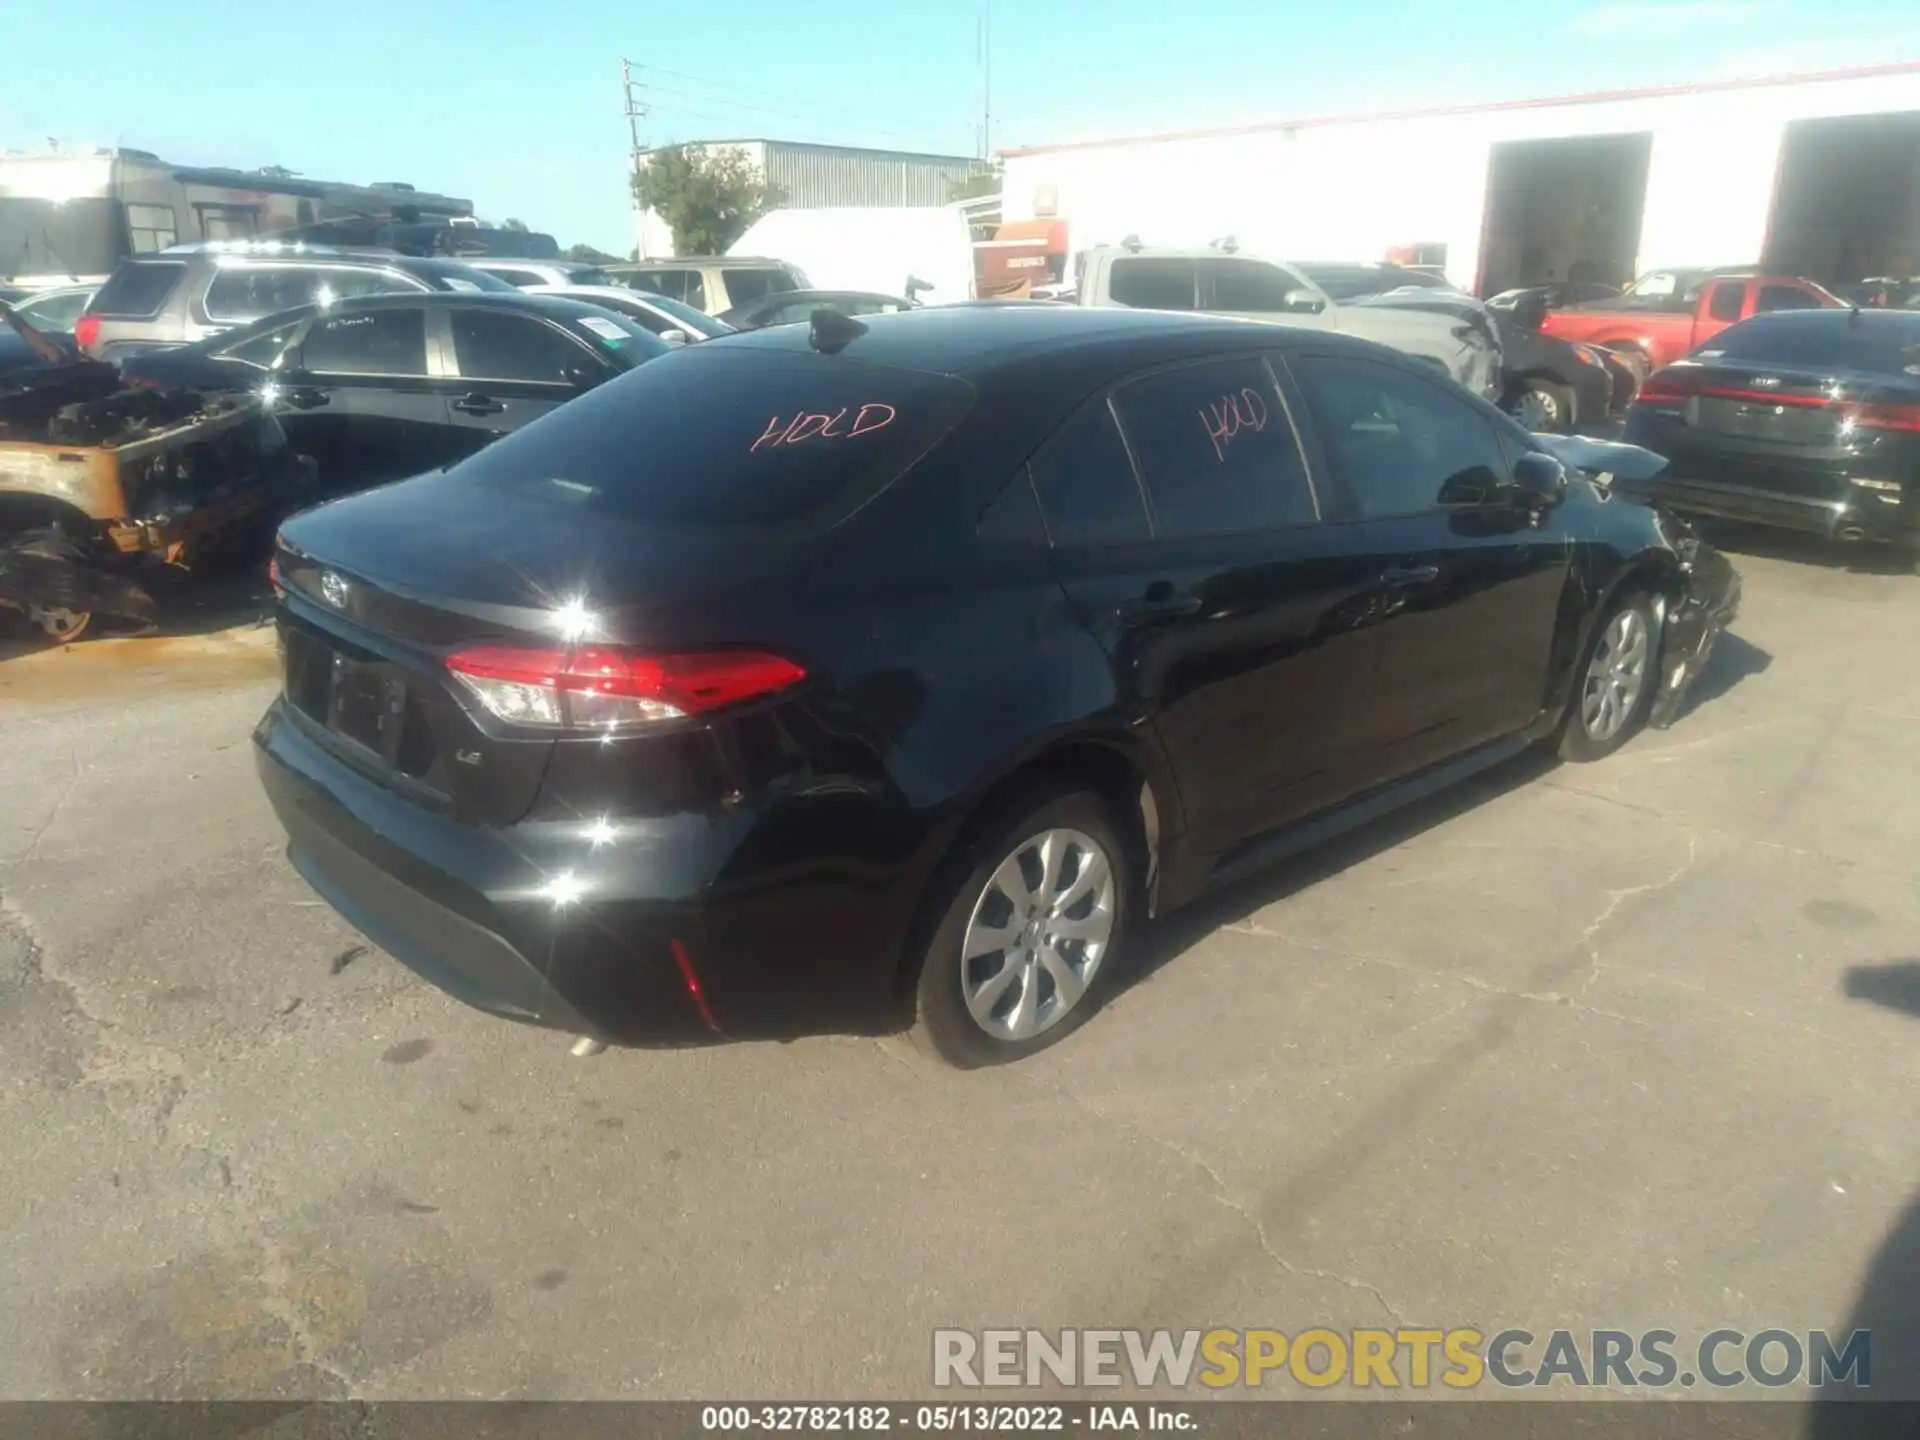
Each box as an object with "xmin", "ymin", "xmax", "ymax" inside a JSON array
[{"xmin": 253, "ymin": 701, "xmax": 937, "ymax": 1043}]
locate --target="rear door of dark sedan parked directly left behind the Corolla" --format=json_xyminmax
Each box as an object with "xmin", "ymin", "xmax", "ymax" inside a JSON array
[{"xmin": 280, "ymin": 305, "xmax": 459, "ymax": 490}]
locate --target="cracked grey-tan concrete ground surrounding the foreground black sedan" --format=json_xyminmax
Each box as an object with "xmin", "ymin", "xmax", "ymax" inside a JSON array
[{"xmin": 0, "ymin": 537, "xmax": 1920, "ymax": 1398}]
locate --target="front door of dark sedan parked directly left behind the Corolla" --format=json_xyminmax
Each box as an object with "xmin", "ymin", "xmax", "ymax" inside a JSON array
[{"xmin": 442, "ymin": 307, "xmax": 612, "ymax": 455}]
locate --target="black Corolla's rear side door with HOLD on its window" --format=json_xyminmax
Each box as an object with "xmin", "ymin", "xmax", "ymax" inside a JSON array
[{"xmin": 1031, "ymin": 355, "xmax": 1397, "ymax": 854}]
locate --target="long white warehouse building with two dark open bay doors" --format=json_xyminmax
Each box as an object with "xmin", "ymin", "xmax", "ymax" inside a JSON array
[{"xmin": 1002, "ymin": 61, "xmax": 1920, "ymax": 294}]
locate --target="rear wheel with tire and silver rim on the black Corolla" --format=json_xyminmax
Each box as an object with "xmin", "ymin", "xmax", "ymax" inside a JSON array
[{"xmin": 914, "ymin": 791, "xmax": 1133, "ymax": 1069}]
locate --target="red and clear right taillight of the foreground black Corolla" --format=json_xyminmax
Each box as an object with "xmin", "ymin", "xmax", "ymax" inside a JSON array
[{"xmin": 447, "ymin": 645, "xmax": 806, "ymax": 730}]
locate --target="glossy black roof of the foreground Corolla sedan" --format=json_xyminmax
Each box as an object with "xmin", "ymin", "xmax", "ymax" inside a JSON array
[{"xmin": 707, "ymin": 301, "xmax": 1392, "ymax": 378}]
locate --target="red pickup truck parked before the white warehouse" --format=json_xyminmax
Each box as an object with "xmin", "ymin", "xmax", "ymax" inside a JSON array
[{"xmin": 1540, "ymin": 271, "xmax": 1845, "ymax": 369}]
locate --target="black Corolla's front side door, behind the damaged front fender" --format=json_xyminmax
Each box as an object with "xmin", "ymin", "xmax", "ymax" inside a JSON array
[{"xmin": 1286, "ymin": 348, "xmax": 1571, "ymax": 783}]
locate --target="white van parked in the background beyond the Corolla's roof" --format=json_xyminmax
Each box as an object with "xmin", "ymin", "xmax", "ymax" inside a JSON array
[{"xmin": 728, "ymin": 205, "xmax": 973, "ymax": 305}]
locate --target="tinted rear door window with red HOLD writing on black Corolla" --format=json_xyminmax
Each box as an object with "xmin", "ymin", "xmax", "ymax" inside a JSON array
[{"xmin": 1114, "ymin": 355, "xmax": 1319, "ymax": 540}]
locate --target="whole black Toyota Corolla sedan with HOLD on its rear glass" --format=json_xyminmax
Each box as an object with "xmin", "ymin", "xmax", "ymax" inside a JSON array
[{"xmin": 255, "ymin": 305, "xmax": 1738, "ymax": 1066}]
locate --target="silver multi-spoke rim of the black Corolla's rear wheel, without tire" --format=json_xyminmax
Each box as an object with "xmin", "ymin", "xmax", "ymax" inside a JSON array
[{"xmin": 960, "ymin": 829, "xmax": 1116, "ymax": 1041}]
